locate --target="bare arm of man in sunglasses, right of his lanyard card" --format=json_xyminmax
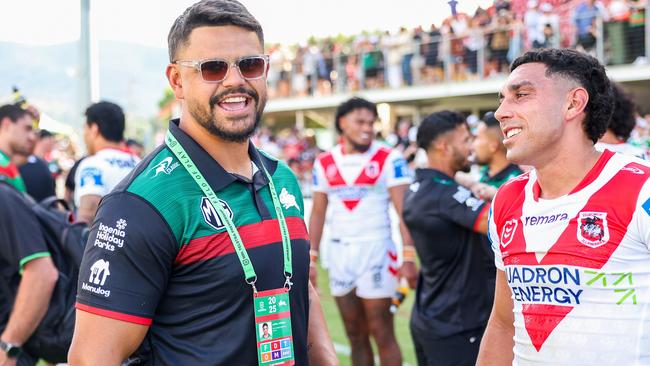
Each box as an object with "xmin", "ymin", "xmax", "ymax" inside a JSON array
[{"xmin": 307, "ymin": 284, "xmax": 339, "ymax": 366}]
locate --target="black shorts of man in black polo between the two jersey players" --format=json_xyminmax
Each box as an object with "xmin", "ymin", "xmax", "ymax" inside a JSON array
[{"xmin": 411, "ymin": 327, "xmax": 485, "ymax": 366}]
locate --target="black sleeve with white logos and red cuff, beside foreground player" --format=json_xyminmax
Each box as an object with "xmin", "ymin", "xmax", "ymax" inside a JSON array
[{"xmin": 440, "ymin": 185, "xmax": 489, "ymax": 230}]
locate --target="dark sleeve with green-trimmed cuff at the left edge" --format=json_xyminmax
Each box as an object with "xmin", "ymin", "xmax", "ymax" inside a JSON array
[{"xmin": 0, "ymin": 183, "xmax": 50, "ymax": 273}]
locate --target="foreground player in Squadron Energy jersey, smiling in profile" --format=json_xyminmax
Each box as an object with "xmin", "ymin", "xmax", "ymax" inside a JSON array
[{"xmin": 478, "ymin": 49, "xmax": 650, "ymax": 366}]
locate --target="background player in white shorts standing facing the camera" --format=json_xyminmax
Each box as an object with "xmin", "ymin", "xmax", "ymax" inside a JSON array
[{"xmin": 309, "ymin": 98, "xmax": 417, "ymax": 366}]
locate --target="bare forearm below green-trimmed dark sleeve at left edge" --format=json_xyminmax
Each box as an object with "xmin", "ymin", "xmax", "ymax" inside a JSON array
[{"xmin": 0, "ymin": 258, "xmax": 58, "ymax": 344}]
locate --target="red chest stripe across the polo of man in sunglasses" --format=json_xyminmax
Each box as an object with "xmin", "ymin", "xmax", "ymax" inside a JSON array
[{"xmin": 175, "ymin": 217, "xmax": 309, "ymax": 265}]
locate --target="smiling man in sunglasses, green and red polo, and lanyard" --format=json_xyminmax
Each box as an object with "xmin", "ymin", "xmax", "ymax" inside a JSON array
[{"xmin": 69, "ymin": 0, "xmax": 338, "ymax": 365}]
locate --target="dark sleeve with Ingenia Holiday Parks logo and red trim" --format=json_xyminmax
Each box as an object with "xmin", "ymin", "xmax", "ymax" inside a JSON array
[{"xmin": 76, "ymin": 192, "xmax": 178, "ymax": 325}]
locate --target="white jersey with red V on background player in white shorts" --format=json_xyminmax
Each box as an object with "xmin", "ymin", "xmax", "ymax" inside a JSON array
[{"xmin": 313, "ymin": 142, "xmax": 412, "ymax": 241}]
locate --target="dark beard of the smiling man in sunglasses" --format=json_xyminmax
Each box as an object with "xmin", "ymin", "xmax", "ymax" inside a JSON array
[{"xmin": 189, "ymin": 88, "xmax": 266, "ymax": 143}]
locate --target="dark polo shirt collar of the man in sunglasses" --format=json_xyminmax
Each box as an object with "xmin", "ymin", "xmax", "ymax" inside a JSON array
[{"xmin": 169, "ymin": 119, "xmax": 278, "ymax": 192}]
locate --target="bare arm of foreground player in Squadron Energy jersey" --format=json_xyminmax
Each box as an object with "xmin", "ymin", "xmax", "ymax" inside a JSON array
[{"xmin": 476, "ymin": 317, "xmax": 514, "ymax": 366}]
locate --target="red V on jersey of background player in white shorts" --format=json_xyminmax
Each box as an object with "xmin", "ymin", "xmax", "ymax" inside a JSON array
[{"xmin": 320, "ymin": 148, "xmax": 390, "ymax": 211}]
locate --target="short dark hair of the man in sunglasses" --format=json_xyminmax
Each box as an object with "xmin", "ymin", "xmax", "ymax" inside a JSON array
[{"xmin": 167, "ymin": 0, "xmax": 264, "ymax": 62}]
